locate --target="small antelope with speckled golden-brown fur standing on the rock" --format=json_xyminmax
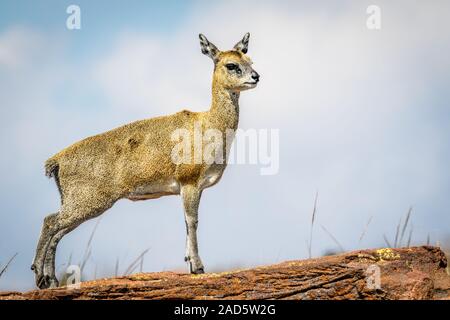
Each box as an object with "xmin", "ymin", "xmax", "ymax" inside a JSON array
[{"xmin": 32, "ymin": 34, "xmax": 259, "ymax": 288}]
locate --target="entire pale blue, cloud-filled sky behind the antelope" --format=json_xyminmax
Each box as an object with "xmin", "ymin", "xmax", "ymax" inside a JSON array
[{"xmin": 0, "ymin": 0, "xmax": 450, "ymax": 290}]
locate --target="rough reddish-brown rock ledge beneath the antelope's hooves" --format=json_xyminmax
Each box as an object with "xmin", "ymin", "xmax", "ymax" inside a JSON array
[{"xmin": 0, "ymin": 246, "xmax": 450, "ymax": 300}]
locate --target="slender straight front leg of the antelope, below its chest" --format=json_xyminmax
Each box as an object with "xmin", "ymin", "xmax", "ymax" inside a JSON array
[{"xmin": 181, "ymin": 185, "xmax": 204, "ymax": 274}]
